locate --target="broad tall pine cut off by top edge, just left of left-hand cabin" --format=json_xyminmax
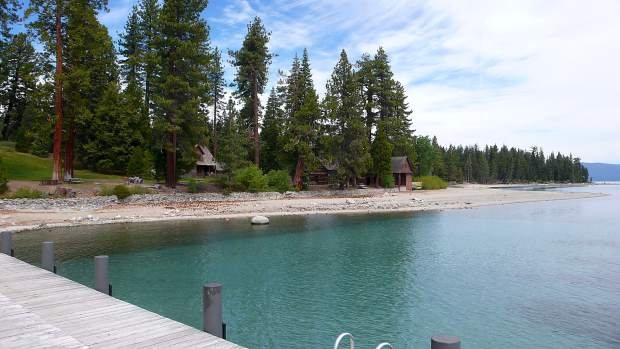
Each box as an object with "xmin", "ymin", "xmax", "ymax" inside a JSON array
[{"xmin": 155, "ymin": 0, "xmax": 211, "ymax": 188}]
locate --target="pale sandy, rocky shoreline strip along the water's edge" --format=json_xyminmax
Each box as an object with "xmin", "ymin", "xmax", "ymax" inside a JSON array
[{"xmin": 0, "ymin": 184, "xmax": 606, "ymax": 232}]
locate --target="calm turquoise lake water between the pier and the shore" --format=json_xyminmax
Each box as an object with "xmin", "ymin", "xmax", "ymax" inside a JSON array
[{"xmin": 15, "ymin": 186, "xmax": 620, "ymax": 348}]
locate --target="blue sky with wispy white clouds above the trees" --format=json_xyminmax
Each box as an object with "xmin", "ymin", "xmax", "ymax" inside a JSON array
[{"xmin": 91, "ymin": 0, "xmax": 620, "ymax": 163}]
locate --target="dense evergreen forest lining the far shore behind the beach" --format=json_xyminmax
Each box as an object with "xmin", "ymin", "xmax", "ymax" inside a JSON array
[{"xmin": 0, "ymin": 0, "xmax": 589, "ymax": 189}]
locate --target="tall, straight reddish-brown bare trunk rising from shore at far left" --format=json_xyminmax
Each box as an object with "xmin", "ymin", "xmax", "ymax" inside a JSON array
[{"xmin": 52, "ymin": 0, "xmax": 62, "ymax": 182}]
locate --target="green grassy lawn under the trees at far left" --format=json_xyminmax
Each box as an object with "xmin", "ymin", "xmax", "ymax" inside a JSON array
[{"xmin": 0, "ymin": 142, "xmax": 123, "ymax": 181}]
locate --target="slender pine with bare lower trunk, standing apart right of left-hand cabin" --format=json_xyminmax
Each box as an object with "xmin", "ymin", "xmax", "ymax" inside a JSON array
[{"xmin": 229, "ymin": 17, "xmax": 272, "ymax": 166}]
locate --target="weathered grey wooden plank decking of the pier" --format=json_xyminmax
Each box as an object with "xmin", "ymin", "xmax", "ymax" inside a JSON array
[{"xmin": 0, "ymin": 254, "xmax": 246, "ymax": 349}]
